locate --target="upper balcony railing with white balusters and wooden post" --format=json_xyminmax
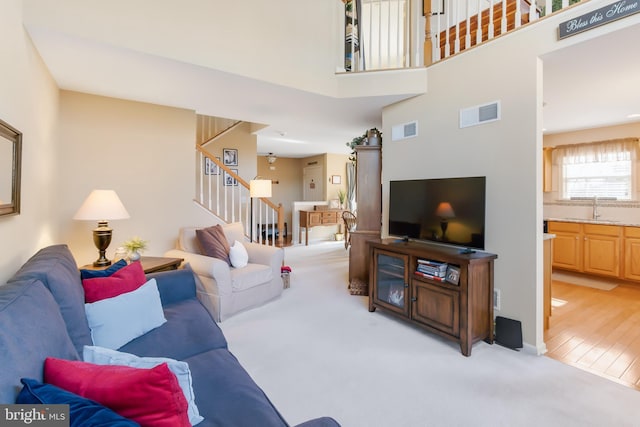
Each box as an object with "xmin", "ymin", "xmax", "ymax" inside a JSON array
[{"xmin": 340, "ymin": 0, "xmax": 580, "ymax": 72}]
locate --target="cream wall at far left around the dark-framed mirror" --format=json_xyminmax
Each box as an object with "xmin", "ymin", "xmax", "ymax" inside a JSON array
[{"xmin": 0, "ymin": 0, "xmax": 59, "ymax": 285}]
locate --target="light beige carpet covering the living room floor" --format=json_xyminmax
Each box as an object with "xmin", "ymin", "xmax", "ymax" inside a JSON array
[{"xmin": 219, "ymin": 242, "xmax": 640, "ymax": 427}]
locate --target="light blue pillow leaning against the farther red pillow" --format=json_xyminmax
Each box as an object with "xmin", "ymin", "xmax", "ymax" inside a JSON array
[{"xmin": 84, "ymin": 279, "xmax": 167, "ymax": 350}]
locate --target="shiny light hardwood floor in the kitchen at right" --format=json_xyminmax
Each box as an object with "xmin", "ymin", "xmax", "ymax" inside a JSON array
[{"xmin": 545, "ymin": 281, "xmax": 640, "ymax": 390}]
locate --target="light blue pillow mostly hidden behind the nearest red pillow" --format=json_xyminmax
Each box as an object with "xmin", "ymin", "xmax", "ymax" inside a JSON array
[{"xmin": 82, "ymin": 345, "xmax": 204, "ymax": 426}]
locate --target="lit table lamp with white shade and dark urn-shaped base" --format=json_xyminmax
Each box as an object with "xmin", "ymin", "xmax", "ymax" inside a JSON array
[{"xmin": 73, "ymin": 190, "xmax": 129, "ymax": 267}]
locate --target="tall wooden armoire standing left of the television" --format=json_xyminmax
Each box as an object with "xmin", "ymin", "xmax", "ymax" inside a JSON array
[{"xmin": 349, "ymin": 145, "xmax": 382, "ymax": 295}]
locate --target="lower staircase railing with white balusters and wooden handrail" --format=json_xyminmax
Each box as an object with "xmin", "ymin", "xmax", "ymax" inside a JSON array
[{"xmin": 195, "ymin": 146, "xmax": 284, "ymax": 246}]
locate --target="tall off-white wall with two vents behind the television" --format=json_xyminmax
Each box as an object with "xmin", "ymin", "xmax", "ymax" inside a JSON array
[{"xmin": 382, "ymin": 0, "xmax": 640, "ymax": 351}]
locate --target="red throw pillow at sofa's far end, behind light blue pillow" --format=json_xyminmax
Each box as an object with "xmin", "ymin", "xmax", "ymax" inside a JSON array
[{"xmin": 82, "ymin": 261, "xmax": 147, "ymax": 303}]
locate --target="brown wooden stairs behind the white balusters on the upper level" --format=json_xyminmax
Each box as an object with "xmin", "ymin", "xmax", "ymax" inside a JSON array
[{"xmin": 437, "ymin": 0, "xmax": 531, "ymax": 58}]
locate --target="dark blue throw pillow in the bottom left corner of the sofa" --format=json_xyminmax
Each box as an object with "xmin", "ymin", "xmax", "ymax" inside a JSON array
[{"xmin": 16, "ymin": 378, "xmax": 140, "ymax": 427}]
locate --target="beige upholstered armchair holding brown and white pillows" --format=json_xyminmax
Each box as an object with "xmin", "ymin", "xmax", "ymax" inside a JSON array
[{"xmin": 165, "ymin": 222, "xmax": 284, "ymax": 322}]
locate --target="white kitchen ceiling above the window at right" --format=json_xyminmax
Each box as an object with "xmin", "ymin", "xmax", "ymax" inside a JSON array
[{"xmin": 543, "ymin": 21, "xmax": 640, "ymax": 133}]
